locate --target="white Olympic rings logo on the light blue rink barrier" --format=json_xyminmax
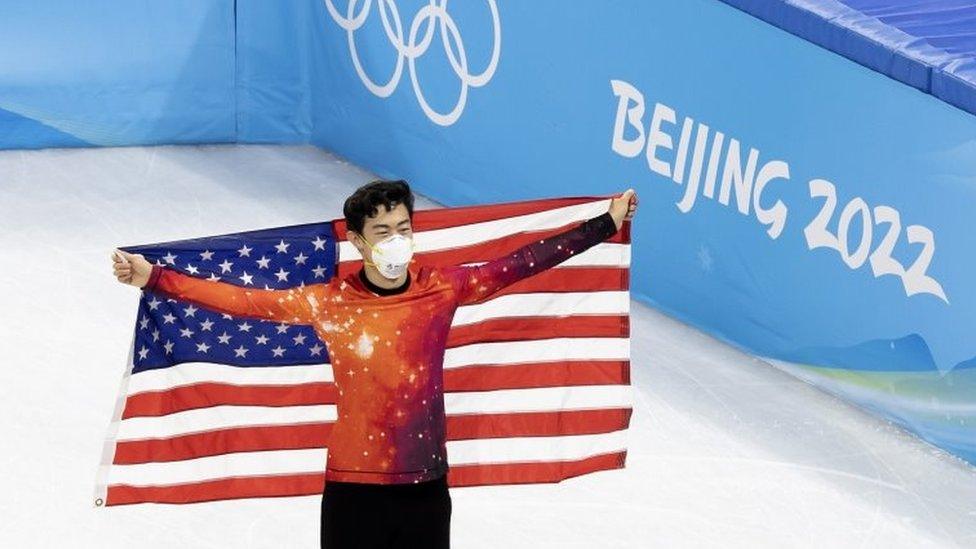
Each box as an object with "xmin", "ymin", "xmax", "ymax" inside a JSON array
[{"xmin": 324, "ymin": 0, "xmax": 502, "ymax": 126}]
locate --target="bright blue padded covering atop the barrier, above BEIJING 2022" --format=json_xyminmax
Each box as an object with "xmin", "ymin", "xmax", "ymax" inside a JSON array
[{"xmin": 722, "ymin": 0, "xmax": 976, "ymax": 114}]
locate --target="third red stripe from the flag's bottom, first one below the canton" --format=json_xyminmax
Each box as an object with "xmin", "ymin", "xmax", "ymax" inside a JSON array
[{"xmin": 122, "ymin": 360, "xmax": 630, "ymax": 419}]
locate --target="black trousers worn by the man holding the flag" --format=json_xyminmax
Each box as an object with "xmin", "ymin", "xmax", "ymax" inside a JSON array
[{"xmin": 321, "ymin": 475, "xmax": 451, "ymax": 549}]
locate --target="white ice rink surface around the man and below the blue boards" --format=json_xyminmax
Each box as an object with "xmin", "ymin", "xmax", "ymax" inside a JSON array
[{"xmin": 0, "ymin": 145, "xmax": 976, "ymax": 549}]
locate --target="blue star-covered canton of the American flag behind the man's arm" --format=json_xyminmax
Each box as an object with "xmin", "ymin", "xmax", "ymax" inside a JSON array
[{"xmin": 120, "ymin": 222, "xmax": 337, "ymax": 373}]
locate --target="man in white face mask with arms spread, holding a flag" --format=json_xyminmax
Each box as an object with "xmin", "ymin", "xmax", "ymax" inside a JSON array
[{"xmin": 113, "ymin": 180, "xmax": 637, "ymax": 549}]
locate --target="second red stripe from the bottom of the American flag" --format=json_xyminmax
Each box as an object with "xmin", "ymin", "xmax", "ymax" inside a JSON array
[{"xmin": 115, "ymin": 408, "xmax": 631, "ymax": 464}]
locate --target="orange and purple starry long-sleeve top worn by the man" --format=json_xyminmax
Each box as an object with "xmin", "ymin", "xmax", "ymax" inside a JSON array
[{"xmin": 143, "ymin": 212, "xmax": 617, "ymax": 484}]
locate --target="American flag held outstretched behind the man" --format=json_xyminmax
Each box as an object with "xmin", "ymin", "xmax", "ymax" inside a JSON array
[{"xmin": 95, "ymin": 196, "xmax": 632, "ymax": 506}]
